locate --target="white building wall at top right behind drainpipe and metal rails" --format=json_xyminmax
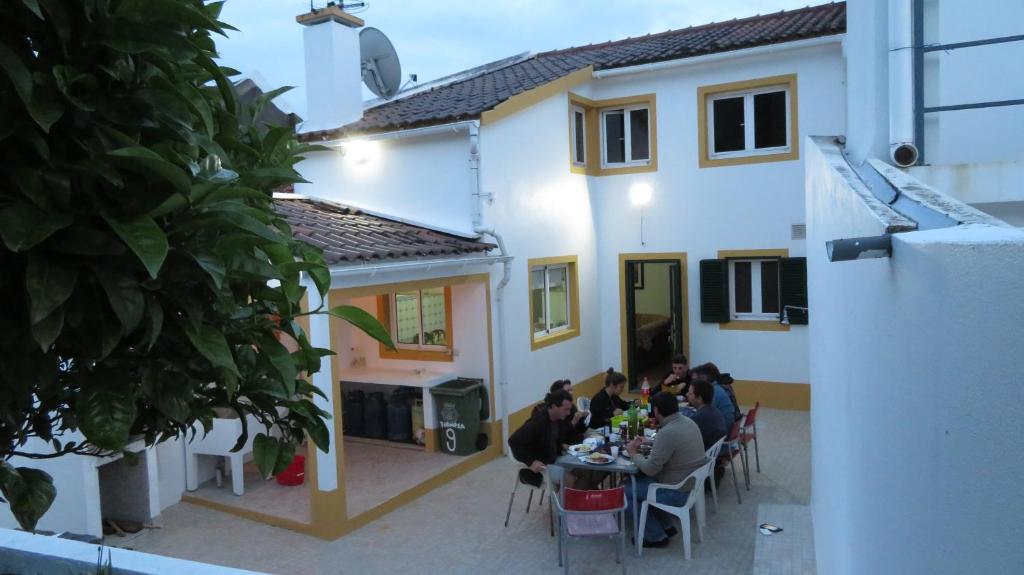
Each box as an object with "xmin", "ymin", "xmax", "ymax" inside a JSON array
[{"xmin": 845, "ymin": 0, "xmax": 1024, "ymax": 165}]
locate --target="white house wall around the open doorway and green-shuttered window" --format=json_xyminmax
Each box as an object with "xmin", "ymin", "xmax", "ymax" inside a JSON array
[{"xmin": 589, "ymin": 43, "xmax": 846, "ymax": 384}]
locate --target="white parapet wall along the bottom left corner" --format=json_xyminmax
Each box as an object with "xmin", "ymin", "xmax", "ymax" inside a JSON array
[{"xmin": 0, "ymin": 529, "xmax": 270, "ymax": 575}]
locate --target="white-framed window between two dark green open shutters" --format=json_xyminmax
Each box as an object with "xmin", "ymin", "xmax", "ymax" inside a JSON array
[{"xmin": 729, "ymin": 259, "xmax": 779, "ymax": 320}]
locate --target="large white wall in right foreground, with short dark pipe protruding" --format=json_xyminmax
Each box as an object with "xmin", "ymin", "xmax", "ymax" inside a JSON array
[{"xmin": 807, "ymin": 142, "xmax": 1024, "ymax": 575}]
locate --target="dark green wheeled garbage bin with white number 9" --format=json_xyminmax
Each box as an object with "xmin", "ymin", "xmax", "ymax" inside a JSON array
[{"xmin": 430, "ymin": 378, "xmax": 490, "ymax": 455}]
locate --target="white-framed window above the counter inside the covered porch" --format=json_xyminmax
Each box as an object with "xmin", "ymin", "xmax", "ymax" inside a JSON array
[{"xmin": 389, "ymin": 288, "xmax": 451, "ymax": 351}]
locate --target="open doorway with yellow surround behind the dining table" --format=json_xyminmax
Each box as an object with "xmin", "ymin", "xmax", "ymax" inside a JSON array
[{"xmin": 621, "ymin": 254, "xmax": 688, "ymax": 391}]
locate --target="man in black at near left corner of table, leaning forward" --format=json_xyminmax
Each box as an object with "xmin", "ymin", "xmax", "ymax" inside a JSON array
[{"xmin": 509, "ymin": 390, "xmax": 572, "ymax": 487}]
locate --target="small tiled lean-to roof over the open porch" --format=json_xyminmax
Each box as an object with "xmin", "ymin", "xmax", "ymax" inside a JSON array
[{"xmin": 273, "ymin": 192, "xmax": 497, "ymax": 267}]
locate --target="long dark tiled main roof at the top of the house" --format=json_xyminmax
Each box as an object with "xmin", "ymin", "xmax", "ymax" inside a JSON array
[{"xmin": 300, "ymin": 2, "xmax": 846, "ymax": 141}]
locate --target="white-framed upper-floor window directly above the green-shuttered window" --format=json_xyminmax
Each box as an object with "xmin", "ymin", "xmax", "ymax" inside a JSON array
[{"xmin": 707, "ymin": 86, "xmax": 792, "ymax": 160}]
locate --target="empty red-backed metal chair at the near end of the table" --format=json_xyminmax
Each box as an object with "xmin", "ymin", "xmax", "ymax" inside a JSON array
[{"xmin": 549, "ymin": 487, "xmax": 626, "ymax": 573}]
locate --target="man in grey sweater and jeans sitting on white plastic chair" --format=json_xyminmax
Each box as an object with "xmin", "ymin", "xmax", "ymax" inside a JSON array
[{"xmin": 626, "ymin": 392, "xmax": 705, "ymax": 547}]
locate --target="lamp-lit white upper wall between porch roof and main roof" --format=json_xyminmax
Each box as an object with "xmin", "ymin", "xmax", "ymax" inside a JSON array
[{"xmin": 295, "ymin": 131, "xmax": 473, "ymax": 234}]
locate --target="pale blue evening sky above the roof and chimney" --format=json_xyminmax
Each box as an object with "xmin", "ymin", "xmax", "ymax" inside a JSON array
[{"xmin": 217, "ymin": 0, "xmax": 823, "ymax": 117}]
